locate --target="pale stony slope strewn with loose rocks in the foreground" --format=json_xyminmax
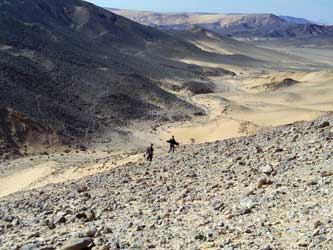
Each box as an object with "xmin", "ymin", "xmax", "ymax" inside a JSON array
[{"xmin": 0, "ymin": 115, "xmax": 333, "ymax": 250}]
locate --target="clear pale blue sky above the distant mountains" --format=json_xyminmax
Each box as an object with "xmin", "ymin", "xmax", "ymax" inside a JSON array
[{"xmin": 86, "ymin": 0, "xmax": 333, "ymax": 24}]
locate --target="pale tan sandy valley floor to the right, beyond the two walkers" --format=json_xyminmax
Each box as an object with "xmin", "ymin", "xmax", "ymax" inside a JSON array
[{"xmin": 161, "ymin": 67, "xmax": 333, "ymax": 143}]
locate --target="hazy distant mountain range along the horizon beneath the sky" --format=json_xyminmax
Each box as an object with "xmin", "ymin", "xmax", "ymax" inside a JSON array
[{"xmin": 112, "ymin": 10, "xmax": 333, "ymax": 38}]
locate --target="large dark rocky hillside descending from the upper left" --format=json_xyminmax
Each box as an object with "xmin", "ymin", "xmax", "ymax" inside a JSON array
[{"xmin": 0, "ymin": 0, "xmax": 240, "ymax": 155}]
